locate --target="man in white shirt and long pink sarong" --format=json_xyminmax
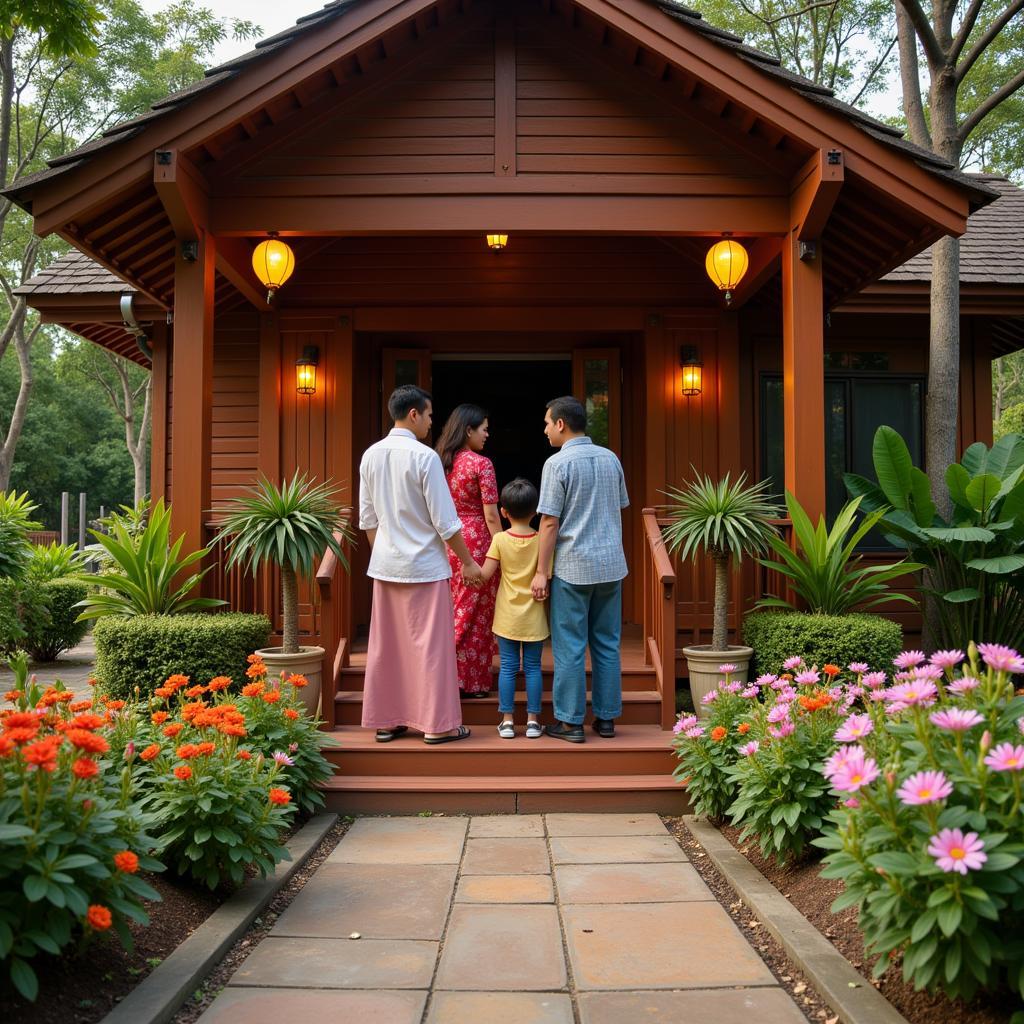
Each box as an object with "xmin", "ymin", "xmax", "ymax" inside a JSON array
[{"xmin": 359, "ymin": 385, "xmax": 482, "ymax": 743}]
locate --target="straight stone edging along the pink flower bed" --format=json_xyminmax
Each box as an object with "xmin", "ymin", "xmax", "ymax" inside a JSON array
[{"xmin": 682, "ymin": 814, "xmax": 907, "ymax": 1024}]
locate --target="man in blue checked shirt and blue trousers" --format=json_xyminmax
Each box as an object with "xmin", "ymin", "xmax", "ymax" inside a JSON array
[{"xmin": 532, "ymin": 396, "xmax": 630, "ymax": 743}]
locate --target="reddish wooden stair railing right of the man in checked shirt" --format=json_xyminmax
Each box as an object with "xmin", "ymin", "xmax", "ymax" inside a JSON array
[{"xmin": 643, "ymin": 509, "xmax": 676, "ymax": 729}]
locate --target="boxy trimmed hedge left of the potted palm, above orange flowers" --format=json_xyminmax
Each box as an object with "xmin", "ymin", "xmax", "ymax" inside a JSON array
[{"xmin": 92, "ymin": 611, "xmax": 270, "ymax": 698}]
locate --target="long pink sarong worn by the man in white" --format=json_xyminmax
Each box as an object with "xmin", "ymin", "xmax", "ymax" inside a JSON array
[{"xmin": 362, "ymin": 580, "xmax": 462, "ymax": 732}]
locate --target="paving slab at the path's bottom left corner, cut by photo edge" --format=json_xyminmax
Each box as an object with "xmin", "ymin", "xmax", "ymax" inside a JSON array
[{"xmin": 200, "ymin": 988, "xmax": 427, "ymax": 1024}]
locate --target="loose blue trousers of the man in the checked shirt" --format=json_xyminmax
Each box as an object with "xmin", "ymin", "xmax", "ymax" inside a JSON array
[{"xmin": 551, "ymin": 577, "xmax": 623, "ymax": 725}]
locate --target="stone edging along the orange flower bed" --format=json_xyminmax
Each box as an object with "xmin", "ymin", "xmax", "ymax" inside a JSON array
[{"xmin": 101, "ymin": 812, "xmax": 338, "ymax": 1024}]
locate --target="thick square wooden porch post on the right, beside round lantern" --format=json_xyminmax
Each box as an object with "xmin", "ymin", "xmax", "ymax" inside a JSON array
[{"xmin": 782, "ymin": 231, "xmax": 825, "ymax": 523}]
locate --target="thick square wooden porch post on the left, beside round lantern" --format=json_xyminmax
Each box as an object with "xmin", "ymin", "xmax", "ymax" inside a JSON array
[{"xmin": 171, "ymin": 231, "xmax": 216, "ymax": 552}]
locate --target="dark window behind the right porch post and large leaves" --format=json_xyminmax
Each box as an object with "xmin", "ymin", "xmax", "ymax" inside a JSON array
[{"xmin": 761, "ymin": 371, "xmax": 925, "ymax": 548}]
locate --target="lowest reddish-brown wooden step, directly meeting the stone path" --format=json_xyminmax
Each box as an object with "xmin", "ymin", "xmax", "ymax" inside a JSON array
[{"xmin": 323, "ymin": 775, "xmax": 689, "ymax": 814}]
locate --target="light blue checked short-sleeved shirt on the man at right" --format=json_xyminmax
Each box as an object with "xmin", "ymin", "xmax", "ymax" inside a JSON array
[{"xmin": 537, "ymin": 437, "xmax": 630, "ymax": 587}]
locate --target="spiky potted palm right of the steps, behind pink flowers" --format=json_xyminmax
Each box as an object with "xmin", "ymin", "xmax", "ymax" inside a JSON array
[{"xmin": 665, "ymin": 473, "xmax": 778, "ymax": 711}]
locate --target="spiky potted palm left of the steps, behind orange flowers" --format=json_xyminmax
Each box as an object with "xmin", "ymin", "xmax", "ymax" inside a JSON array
[{"xmin": 215, "ymin": 471, "xmax": 352, "ymax": 714}]
